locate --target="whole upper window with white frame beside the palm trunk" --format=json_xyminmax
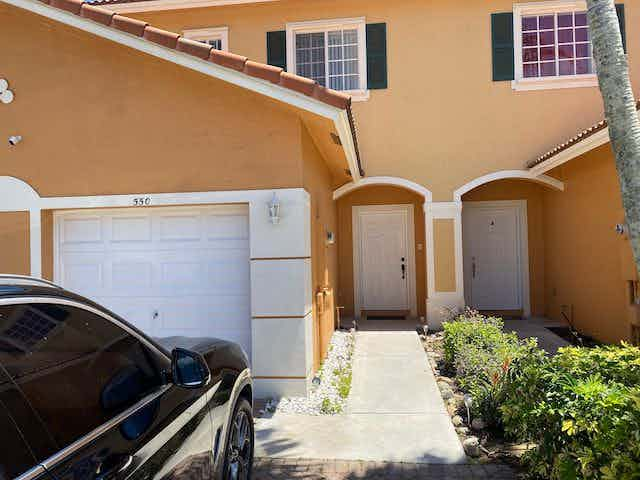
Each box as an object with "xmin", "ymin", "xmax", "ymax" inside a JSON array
[{"xmin": 513, "ymin": 1, "xmax": 597, "ymax": 89}]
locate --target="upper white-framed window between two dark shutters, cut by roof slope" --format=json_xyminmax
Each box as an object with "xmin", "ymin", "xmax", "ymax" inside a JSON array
[{"xmin": 287, "ymin": 18, "xmax": 368, "ymax": 99}]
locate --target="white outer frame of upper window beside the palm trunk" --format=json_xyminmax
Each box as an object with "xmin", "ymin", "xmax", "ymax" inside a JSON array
[{"xmin": 512, "ymin": 0, "xmax": 598, "ymax": 90}]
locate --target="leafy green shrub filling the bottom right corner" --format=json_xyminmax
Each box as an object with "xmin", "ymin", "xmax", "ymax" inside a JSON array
[{"xmin": 500, "ymin": 345, "xmax": 640, "ymax": 480}]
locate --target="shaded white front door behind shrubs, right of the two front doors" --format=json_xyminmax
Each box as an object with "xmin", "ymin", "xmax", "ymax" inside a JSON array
[{"xmin": 462, "ymin": 201, "xmax": 528, "ymax": 314}]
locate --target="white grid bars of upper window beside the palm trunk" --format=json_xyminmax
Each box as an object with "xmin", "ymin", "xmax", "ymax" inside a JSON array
[{"xmin": 520, "ymin": 11, "xmax": 594, "ymax": 78}]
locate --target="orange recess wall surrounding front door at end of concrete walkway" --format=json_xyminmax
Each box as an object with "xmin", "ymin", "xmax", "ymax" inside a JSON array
[{"xmin": 337, "ymin": 186, "xmax": 426, "ymax": 316}]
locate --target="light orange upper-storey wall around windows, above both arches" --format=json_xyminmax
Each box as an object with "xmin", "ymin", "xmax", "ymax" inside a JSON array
[{"xmin": 131, "ymin": 0, "xmax": 640, "ymax": 201}]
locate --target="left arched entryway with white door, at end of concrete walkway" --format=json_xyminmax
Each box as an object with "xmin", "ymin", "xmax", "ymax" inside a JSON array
[{"xmin": 334, "ymin": 177, "xmax": 431, "ymax": 319}]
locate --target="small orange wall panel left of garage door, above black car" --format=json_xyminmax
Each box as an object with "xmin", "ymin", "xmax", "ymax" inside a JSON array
[{"xmin": 0, "ymin": 212, "xmax": 31, "ymax": 275}]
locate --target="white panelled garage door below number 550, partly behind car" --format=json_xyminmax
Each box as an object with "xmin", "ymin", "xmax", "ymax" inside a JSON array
[{"xmin": 55, "ymin": 205, "xmax": 251, "ymax": 358}]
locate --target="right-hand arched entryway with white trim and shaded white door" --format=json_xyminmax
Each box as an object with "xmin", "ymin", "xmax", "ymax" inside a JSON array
[{"xmin": 457, "ymin": 174, "xmax": 563, "ymax": 317}]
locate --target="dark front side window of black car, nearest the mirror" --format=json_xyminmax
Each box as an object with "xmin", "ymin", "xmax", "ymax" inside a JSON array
[{"xmin": 0, "ymin": 303, "xmax": 166, "ymax": 449}]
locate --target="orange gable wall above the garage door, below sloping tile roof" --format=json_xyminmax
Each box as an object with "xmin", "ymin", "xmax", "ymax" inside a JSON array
[{"xmin": 0, "ymin": 6, "xmax": 308, "ymax": 196}]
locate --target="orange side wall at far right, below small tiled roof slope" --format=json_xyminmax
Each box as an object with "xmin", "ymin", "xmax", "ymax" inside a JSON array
[{"xmin": 544, "ymin": 145, "xmax": 636, "ymax": 342}]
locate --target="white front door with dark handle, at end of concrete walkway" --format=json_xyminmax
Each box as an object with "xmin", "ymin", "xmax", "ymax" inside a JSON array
[{"xmin": 353, "ymin": 205, "xmax": 415, "ymax": 316}]
